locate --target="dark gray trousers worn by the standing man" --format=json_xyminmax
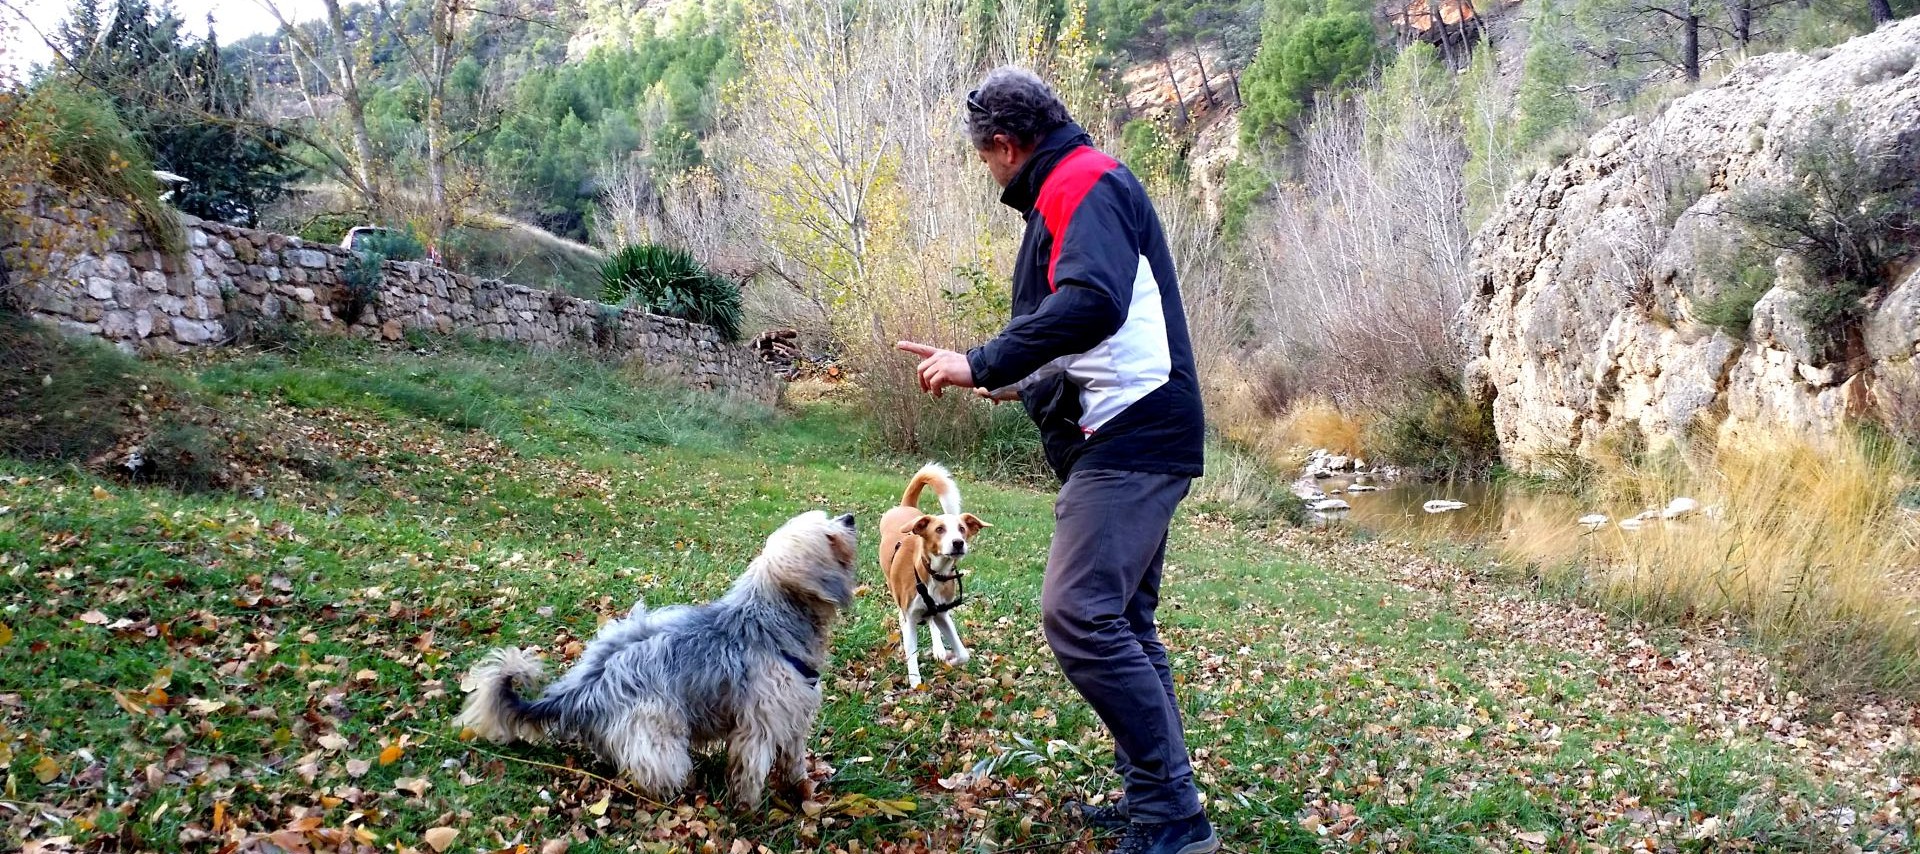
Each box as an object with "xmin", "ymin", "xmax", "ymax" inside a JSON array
[{"xmin": 1041, "ymin": 470, "xmax": 1200, "ymax": 821}]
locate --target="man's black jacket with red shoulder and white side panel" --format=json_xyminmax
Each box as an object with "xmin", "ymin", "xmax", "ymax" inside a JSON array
[{"xmin": 968, "ymin": 125, "xmax": 1206, "ymax": 480}]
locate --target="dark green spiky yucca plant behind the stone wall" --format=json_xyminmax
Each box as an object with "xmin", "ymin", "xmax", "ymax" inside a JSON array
[{"xmin": 601, "ymin": 244, "xmax": 741, "ymax": 342}]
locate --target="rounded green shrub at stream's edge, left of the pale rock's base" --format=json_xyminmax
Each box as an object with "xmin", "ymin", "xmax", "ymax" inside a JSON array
[{"xmin": 1367, "ymin": 374, "xmax": 1500, "ymax": 478}]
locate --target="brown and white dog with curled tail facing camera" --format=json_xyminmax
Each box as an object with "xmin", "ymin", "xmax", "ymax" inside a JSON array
[{"xmin": 879, "ymin": 463, "xmax": 993, "ymax": 687}]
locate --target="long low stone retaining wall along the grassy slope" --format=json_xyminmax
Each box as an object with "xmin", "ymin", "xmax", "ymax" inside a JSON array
[{"xmin": 0, "ymin": 194, "xmax": 781, "ymax": 403}]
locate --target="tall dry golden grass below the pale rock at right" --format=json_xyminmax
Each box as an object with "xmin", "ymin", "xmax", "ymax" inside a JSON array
[{"xmin": 1505, "ymin": 436, "xmax": 1920, "ymax": 693}]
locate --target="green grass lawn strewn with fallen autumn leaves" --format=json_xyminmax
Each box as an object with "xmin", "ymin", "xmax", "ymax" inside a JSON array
[{"xmin": 0, "ymin": 340, "xmax": 1920, "ymax": 852}]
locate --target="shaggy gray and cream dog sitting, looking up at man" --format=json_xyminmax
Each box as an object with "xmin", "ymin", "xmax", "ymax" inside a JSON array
[{"xmin": 453, "ymin": 510, "xmax": 856, "ymax": 810}]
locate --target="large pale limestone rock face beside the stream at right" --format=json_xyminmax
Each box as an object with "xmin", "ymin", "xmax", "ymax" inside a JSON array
[{"xmin": 1457, "ymin": 19, "xmax": 1920, "ymax": 468}]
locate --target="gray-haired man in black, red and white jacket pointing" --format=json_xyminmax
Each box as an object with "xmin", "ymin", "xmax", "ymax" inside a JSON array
[{"xmin": 899, "ymin": 67, "xmax": 1219, "ymax": 854}]
